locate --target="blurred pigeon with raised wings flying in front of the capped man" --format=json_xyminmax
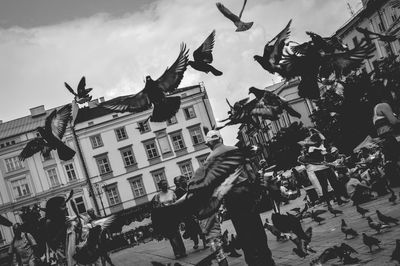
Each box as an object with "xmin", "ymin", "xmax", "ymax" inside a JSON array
[{"xmin": 151, "ymin": 149, "xmax": 249, "ymax": 237}]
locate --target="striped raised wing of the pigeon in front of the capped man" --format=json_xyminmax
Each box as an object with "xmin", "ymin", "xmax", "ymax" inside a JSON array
[{"xmin": 188, "ymin": 149, "xmax": 245, "ymax": 193}]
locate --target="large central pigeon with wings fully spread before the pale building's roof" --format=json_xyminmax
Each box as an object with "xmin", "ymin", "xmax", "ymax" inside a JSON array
[{"xmin": 101, "ymin": 44, "xmax": 189, "ymax": 122}]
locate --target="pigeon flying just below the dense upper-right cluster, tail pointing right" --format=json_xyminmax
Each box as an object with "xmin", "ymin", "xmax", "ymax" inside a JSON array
[{"xmin": 249, "ymin": 87, "xmax": 301, "ymax": 120}]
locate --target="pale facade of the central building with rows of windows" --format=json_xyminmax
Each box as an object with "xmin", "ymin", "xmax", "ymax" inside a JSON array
[{"xmin": 72, "ymin": 86, "xmax": 215, "ymax": 214}]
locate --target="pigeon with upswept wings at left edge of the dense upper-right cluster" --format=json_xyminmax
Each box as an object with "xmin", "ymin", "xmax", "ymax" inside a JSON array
[{"xmin": 254, "ymin": 20, "xmax": 292, "ymax": 74}]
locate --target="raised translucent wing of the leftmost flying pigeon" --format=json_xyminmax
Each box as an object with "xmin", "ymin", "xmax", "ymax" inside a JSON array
[{"xmin": 45, "ymin": 104, "xmax": 72, "ymax": 139}]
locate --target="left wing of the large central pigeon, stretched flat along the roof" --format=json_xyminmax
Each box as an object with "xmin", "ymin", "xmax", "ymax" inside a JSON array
[{"xmin": 100, "ymin": 90, "xmax": 151, "ymax": 113}]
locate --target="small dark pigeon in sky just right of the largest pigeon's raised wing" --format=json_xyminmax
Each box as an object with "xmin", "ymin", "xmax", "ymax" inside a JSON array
[{"xmin": 188, "ymin": 30, "xmax": 222, "ymax": 76}]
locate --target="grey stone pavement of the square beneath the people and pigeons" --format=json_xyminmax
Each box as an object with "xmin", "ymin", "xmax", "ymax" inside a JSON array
[{"xmin": 112, "ymin": 188, "xmax": 400, "ymax": 266}]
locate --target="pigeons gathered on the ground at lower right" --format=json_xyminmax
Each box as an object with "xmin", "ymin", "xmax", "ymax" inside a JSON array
[{"xmin": 264, "ymin": 194, "xmax": 400, "ymax": 265}]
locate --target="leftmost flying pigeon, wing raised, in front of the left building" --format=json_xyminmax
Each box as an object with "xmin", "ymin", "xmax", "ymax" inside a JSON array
[{"xmin": 19, "ymin": 105, "xmax": 75, "ymax": 161}]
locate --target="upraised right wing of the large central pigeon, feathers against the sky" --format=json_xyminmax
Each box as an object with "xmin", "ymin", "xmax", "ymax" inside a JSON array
[{"xmin": 156, "ymin": 43, "xmax": 189, "ymax": 92}]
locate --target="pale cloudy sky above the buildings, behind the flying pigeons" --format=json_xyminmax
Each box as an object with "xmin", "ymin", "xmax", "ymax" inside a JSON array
[{"xmin": 0, "ymin": 0, "xmax": 361, "ymax": 144}]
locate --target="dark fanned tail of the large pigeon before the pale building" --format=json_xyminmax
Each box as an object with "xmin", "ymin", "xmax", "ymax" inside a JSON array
[{"xmin": 150, "ymin": 96, "xmax": 181, "ymax": 122}]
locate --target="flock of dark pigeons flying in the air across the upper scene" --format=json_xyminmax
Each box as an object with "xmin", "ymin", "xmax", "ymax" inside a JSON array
[{"xmin": 16, "ymin": 0, "xmax": 400, "ymax": 160}]
